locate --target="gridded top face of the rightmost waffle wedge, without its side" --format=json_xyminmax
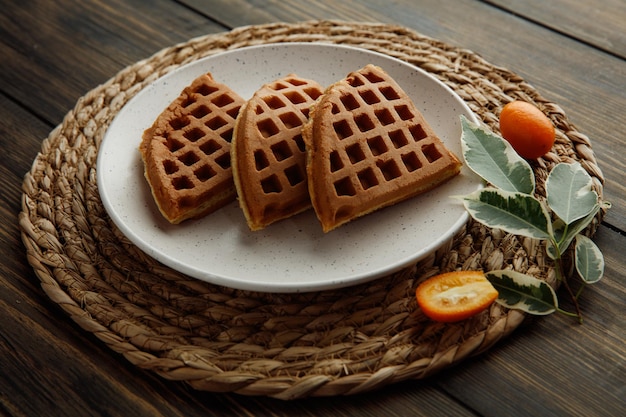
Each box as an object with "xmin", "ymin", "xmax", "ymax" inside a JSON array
[{"xmin": 330, "ymin": 67, "xmax": 442, "ymax": 197}]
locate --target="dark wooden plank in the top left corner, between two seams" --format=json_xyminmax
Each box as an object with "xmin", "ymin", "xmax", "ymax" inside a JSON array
[{"xmin": 0, "ymin": 0, "xmax": 219, "ymax": 124}]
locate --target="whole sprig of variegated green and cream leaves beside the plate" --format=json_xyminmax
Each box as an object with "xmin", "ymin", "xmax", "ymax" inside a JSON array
[{"xmin": 461, "ymin": 116, "xmax": 610, "ymax": 323}]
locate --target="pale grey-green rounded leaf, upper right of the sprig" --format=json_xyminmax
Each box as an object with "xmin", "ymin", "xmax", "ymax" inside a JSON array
[{"xmin": 546, "ymin": 162, "xmax": 598, "ymax": 224}]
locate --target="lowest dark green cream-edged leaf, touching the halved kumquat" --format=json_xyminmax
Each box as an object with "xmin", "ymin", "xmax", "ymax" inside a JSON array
[{"xmin": 485, "ymin": 270, "xmax": 559, "ymax": 315}]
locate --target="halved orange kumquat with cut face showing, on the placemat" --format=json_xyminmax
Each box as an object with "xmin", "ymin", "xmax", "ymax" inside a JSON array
[{"xmin": 415, "ymin": 271, "xmax": 498, "ymax": 322}]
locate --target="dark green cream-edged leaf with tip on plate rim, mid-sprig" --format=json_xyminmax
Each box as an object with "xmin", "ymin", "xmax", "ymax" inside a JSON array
[{"xmin": 463, "ymin": 187, "xmax": 552, "ymax": 239}]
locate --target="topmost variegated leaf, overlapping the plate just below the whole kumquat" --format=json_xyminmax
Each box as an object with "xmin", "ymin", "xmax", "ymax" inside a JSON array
[{"xmin": 461, "ymin": 116, "xmax": 535, "ymax": 194}]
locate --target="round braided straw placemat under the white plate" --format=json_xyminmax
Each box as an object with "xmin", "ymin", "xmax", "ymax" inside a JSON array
[{"xmin": 19, "ymin": 21, "xmax": 604, "ymax": 399}]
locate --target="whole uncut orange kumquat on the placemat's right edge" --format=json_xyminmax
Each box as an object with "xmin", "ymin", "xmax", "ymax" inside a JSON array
[{"xmin": 500, "ymin": 100, "xmax": 555, "ymax": 159}]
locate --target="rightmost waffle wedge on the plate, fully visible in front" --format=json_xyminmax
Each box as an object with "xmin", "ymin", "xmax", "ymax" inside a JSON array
[{"xmin": 303, "ymin": 65, "xmax": 461, "ymax": 232}]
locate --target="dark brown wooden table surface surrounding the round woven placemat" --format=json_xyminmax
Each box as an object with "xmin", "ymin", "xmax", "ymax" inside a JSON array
[{"xmin": 0, "ymin": 0, "xmax": 626, "ymax": 417}]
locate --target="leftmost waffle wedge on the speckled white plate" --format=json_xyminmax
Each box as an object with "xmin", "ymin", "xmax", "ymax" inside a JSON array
[{"xmin": 139, "ymin": 74, "xmax": 244, "ymax": 224}]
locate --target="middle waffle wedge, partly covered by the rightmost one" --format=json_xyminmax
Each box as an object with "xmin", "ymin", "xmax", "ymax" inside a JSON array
[{"xmin": 231, "ymin": 74, "xmax": 323, "ymax": 230}]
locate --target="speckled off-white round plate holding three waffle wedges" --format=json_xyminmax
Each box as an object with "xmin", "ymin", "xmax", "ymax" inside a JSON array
[{"xmin": 97, "ymin": 43, "xmax": 482, "ymax": 292}]
